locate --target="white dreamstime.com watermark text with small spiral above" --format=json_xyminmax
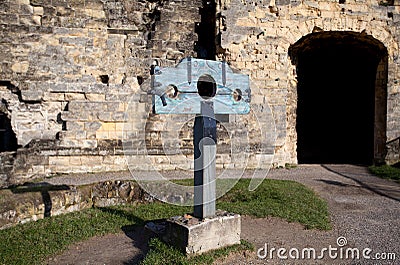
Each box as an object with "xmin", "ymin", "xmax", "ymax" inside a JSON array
[{"xmin": 257, "ymin": 236, "xmax": 397, "ymax": 261}]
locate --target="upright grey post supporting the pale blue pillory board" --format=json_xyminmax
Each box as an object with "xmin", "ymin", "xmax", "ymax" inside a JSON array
[{"xmin": 194, "ymin": 101, "xmax": 217, "ymax": 219}]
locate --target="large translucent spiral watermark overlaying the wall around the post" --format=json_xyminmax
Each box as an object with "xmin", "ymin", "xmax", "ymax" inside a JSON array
[{"xmin": 122, "ymin": 77, "xmax": 276, "ymax": 206}]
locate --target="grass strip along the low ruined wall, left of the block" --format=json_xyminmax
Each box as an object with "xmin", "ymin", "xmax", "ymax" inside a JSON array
[{"xmin": 0, "ymin": 203, "xmax": 191, "ymax": 264}]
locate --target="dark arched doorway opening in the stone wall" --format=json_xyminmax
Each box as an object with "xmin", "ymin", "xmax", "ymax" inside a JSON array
[{"xmin": 289, "ymin": 31, "xmax": 387, "ymax": 164}]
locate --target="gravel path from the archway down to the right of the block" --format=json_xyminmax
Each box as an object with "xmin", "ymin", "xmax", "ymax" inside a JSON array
[{"xmin": 218, "ymin": 165, "xmax": 400, "ymax": 264}]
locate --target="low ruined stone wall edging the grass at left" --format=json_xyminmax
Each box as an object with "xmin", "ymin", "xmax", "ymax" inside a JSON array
[{"xmin": 0, "ymin": 181, "xmax": 146, "ymax": 229}]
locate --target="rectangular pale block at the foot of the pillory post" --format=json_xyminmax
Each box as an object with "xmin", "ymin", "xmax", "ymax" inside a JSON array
[{"xmin": 162, "ymin": 212, "xmax": 241, "ymax": 256}]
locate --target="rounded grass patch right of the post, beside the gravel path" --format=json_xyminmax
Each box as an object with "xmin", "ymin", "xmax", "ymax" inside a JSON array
[{"xmin": 217, "ymin": 179, "xmax": 331, "ymax": 230}]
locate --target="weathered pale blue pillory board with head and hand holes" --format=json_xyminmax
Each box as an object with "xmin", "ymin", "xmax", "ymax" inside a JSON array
[{"xmin": 152, "ymin": 58, "xmax": 251, "ymax": 114}]
